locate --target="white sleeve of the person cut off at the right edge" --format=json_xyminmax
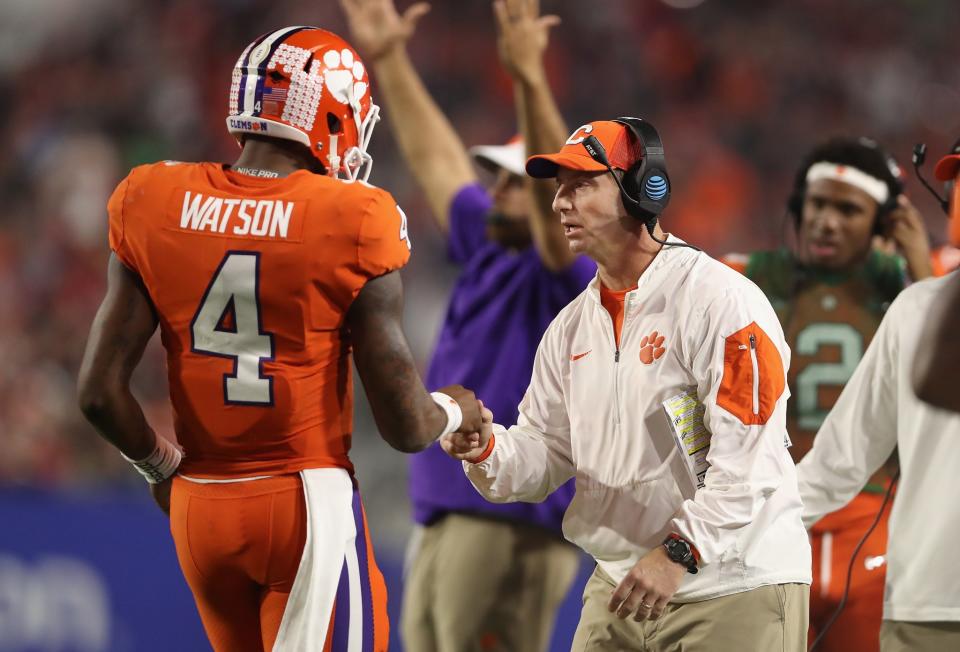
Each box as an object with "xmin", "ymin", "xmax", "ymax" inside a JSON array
[{"xmin": 797, "ymin": 301, "xmax": 902, "ymax": 528}]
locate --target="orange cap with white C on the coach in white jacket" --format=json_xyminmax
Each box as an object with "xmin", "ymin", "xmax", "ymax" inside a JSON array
[{"xmin": 527, "ymin": 120, "xmax": 643, "ymax": 179}]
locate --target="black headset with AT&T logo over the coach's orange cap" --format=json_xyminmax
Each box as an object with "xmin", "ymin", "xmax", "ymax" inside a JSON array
[{"xmin": 583, "ymin": 117, "xmax": 700, "ymax": 251}]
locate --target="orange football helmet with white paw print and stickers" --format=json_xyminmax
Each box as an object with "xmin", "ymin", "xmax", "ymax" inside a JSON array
[{"xmin": 227, "ymin": 27, "xmax": 380, "ymax": 181}]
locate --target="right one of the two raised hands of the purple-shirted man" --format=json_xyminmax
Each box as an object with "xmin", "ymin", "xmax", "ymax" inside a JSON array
[{"xmin": 493, "ymin": 0, "xmax": 560, "ymax": 83}]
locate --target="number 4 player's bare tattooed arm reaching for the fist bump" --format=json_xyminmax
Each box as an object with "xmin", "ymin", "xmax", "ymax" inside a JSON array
[{"xmin": 347, "ymin": 272, "xmax": 481, "ymax": 453}]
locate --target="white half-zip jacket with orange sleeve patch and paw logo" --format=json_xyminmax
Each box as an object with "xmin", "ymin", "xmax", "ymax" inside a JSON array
[{"xmin": 464, "ymin": 236, "xmax": 810, "ymax": 602}]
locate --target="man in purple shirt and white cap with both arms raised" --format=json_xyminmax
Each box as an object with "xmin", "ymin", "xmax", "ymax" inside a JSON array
[{"xmin": 341, "ymin": 0, "xmax": 596, "ymax": 652}]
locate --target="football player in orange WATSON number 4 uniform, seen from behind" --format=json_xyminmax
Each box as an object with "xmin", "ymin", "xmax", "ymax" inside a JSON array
[{"xmin": 79, "ymin": 27, "xmax": 481, "ymax": 652}]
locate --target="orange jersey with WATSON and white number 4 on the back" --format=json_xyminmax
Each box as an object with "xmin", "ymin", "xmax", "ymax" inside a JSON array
[{"xmin": 108, "ymin": 162, "xmax": 410, "ymax": 478}]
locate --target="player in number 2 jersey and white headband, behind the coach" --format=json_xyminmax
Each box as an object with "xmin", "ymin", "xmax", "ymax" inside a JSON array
[{"xmin": 727, "ymin": 138, "xmax": 932, "ymax": 652}]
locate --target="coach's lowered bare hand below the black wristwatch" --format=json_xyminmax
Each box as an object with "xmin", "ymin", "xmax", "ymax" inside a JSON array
[{"xmin": 607, "ymin": 546, "xmax": 687, "ymax": 622}]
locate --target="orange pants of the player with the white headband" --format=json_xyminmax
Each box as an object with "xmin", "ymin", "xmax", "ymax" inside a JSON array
[{"xmin": 807, "ymin": 493, "xmax": 890, "ymax": 652}]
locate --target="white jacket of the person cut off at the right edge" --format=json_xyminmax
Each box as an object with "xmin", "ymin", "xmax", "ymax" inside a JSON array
[{"xmin": 797, "ymin": 278, "xmax": 960, "ymax": 621}]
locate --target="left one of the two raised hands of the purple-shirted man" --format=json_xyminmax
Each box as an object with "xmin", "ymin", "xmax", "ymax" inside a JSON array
[{"xmin": 339, "ymin": 0, "xmax": 430, "ymax": 63}]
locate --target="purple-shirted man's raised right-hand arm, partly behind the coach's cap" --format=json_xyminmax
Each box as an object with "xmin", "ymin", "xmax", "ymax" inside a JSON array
[{"xmin": 493, "ymin": 0, "xmax": 575, "ymax": 271}]
